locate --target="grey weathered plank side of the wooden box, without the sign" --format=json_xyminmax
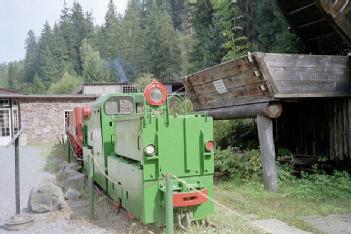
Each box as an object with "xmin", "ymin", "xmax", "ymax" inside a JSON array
[{"xmin": 261, "ymin": 53, "xmax": 351, "ymax": 97}]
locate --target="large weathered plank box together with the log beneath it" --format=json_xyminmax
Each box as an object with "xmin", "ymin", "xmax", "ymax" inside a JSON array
[{"xmin": 184, "ymin": 52, "xmax": 351, "ymax": 119}]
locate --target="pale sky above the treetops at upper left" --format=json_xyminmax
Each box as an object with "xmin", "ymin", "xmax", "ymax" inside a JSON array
[{"xmin": 0, "ymin": 0, "xmax": 128, "ymax": 63}]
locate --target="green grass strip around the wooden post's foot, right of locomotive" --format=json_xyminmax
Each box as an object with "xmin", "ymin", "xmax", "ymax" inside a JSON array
[{"xmin": 215, "ymin": 172, "xmax": 351, "ymax": 233}]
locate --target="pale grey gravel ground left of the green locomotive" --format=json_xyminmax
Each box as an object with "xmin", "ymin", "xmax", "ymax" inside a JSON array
[{"xmin": 0, "ymin": 146, "xmax": 153, "ymax": 234}]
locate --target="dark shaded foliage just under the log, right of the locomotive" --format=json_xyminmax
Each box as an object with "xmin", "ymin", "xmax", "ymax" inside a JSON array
[{"xmin": 213, "ymin": 119, "xmax": 259, "ymax": 150}]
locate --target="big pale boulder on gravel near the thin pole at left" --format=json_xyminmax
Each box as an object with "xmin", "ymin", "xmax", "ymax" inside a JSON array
[{"xmin": 28, "ymin": 182, "xmax": 65, "ymax": 213}]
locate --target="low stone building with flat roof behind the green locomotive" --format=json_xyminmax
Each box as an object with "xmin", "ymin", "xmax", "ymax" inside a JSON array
[{"xmin": 0, "ymin": 82, "xmax": 184, "ymax": 146}]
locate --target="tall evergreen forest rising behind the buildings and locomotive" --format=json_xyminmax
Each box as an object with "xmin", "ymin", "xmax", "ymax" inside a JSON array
[{"xmin": 0, "ymin": 0, "xmax": 302, "ymax": 93}]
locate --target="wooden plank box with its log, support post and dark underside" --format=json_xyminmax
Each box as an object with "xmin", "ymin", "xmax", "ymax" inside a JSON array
[{"xmin": 184, "ymin": 53, "xmax": 351, "ymax": 191}]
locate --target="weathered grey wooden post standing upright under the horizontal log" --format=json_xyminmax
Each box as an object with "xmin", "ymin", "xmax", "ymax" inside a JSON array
[{"xmin": 257, "ymin": 115, "xmax": 278, "ymax": 192}]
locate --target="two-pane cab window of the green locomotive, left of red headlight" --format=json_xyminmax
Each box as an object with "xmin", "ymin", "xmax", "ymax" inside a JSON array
[{"xmin": 104, "ymin": 96, "xmax": 134, "ymax": 115}]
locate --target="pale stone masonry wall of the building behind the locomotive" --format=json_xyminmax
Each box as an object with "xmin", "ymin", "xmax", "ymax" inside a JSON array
[{"xmin": 20, "ymin": 98, "xmax": 94, "ymax": 144}]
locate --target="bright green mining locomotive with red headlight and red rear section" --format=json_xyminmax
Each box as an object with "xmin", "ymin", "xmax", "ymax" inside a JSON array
[{"xmin": 67, "ymin": 81, "xmax": 214, "ymax": 229}]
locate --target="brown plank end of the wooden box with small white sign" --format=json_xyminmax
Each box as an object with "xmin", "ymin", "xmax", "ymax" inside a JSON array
[{"xmin": 184, "ymin": 56, "xmax": 271, "ymax": 110}]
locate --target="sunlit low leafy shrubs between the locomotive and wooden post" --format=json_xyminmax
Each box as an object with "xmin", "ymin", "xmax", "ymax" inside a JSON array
[{"xmin": 215, "ymin": 147, "xmax": 262, "ymax": 180}]
